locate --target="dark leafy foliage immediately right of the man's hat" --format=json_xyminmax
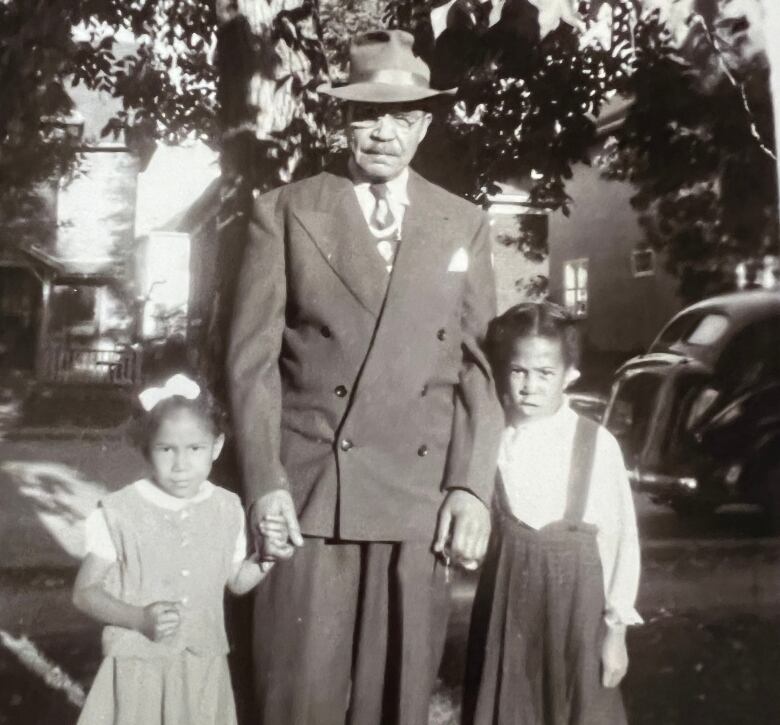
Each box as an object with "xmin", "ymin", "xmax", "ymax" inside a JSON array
[{"xmin": 386, "ymin": 0, "xmax": 638, "ymax": 266}]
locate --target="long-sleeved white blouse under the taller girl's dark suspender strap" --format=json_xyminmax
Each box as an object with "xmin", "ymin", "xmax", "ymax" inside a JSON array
[{"xmin": 498, "ymin": 404, "xmax": 642, "ymax": 626}]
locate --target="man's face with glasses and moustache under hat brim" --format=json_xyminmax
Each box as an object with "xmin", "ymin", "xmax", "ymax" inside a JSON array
[{"xmin": 346, "ymin": 103, "xmax": 431, "ymax": 182}]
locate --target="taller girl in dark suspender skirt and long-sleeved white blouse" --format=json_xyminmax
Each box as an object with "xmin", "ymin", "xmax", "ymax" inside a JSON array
[{"xmin": 464, "ymin": 303, "xmax": 641, "ymax": 725}]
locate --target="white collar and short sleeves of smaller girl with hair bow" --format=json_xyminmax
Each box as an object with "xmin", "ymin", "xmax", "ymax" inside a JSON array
[{"xmin": 84, "ymin": 478, "xmax": 247, "ymax": 564}]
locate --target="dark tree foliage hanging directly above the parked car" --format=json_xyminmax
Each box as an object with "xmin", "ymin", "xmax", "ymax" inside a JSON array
[{"xmin": 599, "ymin": 2, "xmax": 778, "ymax": 301}]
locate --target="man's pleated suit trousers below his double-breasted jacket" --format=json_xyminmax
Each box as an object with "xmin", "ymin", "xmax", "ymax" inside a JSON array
[{"xmin": 253, "ymin": 538, "xmax": 449, "ymax": 725}]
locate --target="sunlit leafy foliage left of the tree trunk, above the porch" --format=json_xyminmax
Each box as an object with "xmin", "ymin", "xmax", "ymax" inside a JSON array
[{"xmin": 0, "ymin": 0, "xmax": 218, "ymax": 226}]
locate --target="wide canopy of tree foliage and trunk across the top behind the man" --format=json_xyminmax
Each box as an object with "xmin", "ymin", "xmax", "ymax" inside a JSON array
[{"xmin": 0, "ymin": 0, "xmax": 777, "ymax": 306}]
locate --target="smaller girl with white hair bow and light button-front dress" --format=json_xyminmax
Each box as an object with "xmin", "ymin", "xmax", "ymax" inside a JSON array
[{"xmin": 73, "ymin": 375, "xmax": 286, "ymax": 725}]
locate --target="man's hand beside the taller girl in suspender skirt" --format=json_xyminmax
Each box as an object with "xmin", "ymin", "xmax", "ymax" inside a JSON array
[{"xmin": 433, "ymin": 488, "xmax": 490, "ymax": 569}]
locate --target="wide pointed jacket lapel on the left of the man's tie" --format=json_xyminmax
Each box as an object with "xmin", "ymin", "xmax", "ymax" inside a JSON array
[{"xmin": 293, "ymin": 174, "xmax": 387, "ymax": 317}]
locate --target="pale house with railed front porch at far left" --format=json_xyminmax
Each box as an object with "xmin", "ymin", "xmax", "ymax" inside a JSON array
[{"xmin": 0, "ymin": 83, "xmax": 139, "ymax": 383}]
